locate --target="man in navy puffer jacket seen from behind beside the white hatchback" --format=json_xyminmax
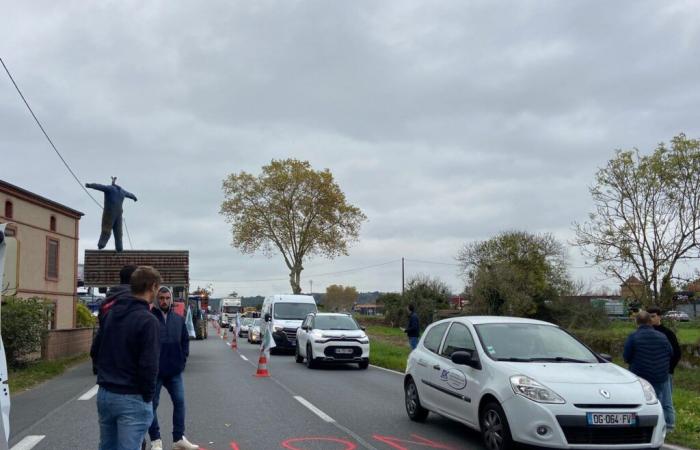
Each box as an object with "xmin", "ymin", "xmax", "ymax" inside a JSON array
[{"xmin": 623, "ymin": 311, "xmax": 674, "ymax": 431}]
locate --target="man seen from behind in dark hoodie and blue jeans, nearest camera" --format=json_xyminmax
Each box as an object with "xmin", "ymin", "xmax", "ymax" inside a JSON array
[{"xmin": 94, "ymin": 266, "xmax": 161, "ymax": 450}]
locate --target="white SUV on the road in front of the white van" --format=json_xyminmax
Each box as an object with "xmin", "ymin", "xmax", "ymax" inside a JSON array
[{"xmin": 296, "ymin": 313, "xmax": 369, "ymax": 369}]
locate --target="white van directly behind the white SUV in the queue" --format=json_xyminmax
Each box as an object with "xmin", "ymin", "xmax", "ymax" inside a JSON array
[{"xmin": 260, "ymin": 294, "xmax": 318, "ymax": 349}]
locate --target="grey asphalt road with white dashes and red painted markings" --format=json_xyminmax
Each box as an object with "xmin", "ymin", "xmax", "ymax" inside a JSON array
[{"xmin": 10, "ymin": 324, "xmax": 680, "ymax": 450}]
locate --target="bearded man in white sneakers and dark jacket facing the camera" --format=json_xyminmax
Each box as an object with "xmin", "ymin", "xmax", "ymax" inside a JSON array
[{"xmin": 148, "ymin": 287, "xmax": 199, "ymax": 450}]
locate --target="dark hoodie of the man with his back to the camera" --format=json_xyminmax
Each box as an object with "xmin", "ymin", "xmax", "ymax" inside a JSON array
[{"xmin": 93, "ymin": 295, "xmax": 160, "ymax": 402}]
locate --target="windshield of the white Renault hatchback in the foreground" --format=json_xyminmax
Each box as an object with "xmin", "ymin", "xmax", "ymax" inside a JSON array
[{"xmin": 475, "ymin": 323, "xmax": 598, "ymax": 363}]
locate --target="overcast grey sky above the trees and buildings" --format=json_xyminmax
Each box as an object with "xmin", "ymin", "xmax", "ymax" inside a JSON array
[{"xmin": 0, "ymin": 0, "xmax": 700, "ymax": 296}]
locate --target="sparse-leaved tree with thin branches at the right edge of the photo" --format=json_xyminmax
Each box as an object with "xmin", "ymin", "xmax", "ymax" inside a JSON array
[{"xmin": 574, "ymin": 134, "xmax": 700, "ymax": 305}]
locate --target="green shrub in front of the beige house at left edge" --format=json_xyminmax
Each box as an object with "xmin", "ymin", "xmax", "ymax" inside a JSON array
[{"xmin": 2, "ymin": 297, "xmax": 48, "ymax": 367}]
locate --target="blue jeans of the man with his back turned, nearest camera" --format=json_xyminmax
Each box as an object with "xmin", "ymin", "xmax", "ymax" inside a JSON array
[{"xmin": 97, "ymin": 387, "xmax": 153, "ymax": 450}]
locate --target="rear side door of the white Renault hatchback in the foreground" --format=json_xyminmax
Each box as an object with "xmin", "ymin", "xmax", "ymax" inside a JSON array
[{"xmin": 415, "ymin": 322, "xmax": 449, "ymax": 410}]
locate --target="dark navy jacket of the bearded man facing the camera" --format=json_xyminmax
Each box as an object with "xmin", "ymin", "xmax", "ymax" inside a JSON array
[{"xmin": 151, "ymin": 287, "xmax": 190, "ymax": 378}]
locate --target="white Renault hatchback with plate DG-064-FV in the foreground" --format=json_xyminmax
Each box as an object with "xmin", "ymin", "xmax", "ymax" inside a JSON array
[{"xmin": 404, "ymin": 316, "xmax": 666, "ymax": 450}]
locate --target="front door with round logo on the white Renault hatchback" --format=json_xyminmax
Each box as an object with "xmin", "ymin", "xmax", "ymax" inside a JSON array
[{"xmin": 431, "ymin": 321, "xmax": 480, "ymax": 424}]
